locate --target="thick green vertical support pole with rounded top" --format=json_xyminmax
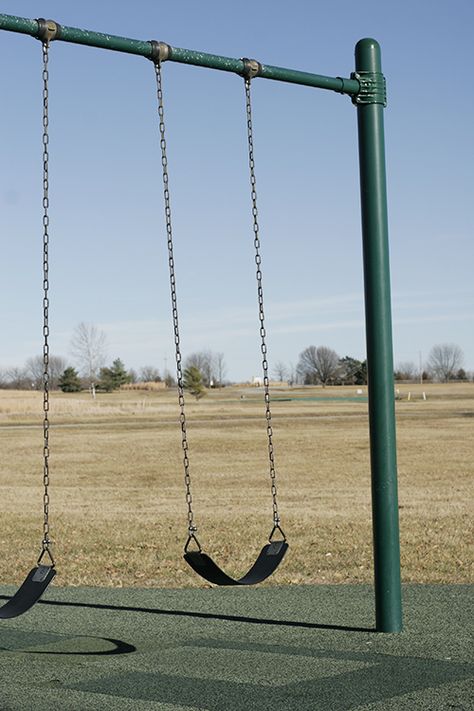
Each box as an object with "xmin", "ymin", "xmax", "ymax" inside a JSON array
[{"xmin": 352, "ymin": 39, "xmax": 402, "ymax": 632}]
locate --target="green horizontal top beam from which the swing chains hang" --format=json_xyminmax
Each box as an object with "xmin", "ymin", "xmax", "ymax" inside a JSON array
[{"xmin": 0, "ymin": 14, "xmax": 360, "ymax": 95}]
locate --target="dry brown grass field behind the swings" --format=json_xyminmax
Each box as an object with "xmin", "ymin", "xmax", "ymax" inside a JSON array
[{"xmin": 0, "ymin": 383, "xmax": 474, "ymax": 587}]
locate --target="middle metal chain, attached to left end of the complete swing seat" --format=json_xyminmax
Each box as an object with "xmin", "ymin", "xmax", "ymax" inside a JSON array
[{"xmin": 151, "ymin": 61, "xmax": 197, "ymax": 550}]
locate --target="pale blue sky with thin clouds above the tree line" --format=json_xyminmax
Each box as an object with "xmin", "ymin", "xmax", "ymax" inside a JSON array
[{"xmin": 0, "ymin": 0, "xmax": 474, "ymax": 380}]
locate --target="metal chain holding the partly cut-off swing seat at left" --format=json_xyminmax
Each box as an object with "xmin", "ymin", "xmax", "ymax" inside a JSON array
[{"xmin": 38, "ymin": 41, "xmax": 54, "ymax": 565}]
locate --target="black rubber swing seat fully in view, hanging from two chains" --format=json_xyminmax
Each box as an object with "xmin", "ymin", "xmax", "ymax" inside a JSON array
[{"xmin": 184, "ymin": 541, "xmax": 288, "ymax": 585}]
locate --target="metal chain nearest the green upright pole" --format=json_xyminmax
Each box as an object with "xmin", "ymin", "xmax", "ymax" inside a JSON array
[{"xmin": 245, "ymin": 76, "xmax": 284, "ymax": 539}]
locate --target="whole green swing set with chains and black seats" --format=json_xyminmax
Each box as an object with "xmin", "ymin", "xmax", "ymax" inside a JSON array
[{"xmin": 0, "ymin": 14, "xmax": 402, "ymax": 632}]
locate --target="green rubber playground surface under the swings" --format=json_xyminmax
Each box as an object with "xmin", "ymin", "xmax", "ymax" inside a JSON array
[{"xmin": 0, "ymin": 585, "xmax": 474, "ymax": 711}]
